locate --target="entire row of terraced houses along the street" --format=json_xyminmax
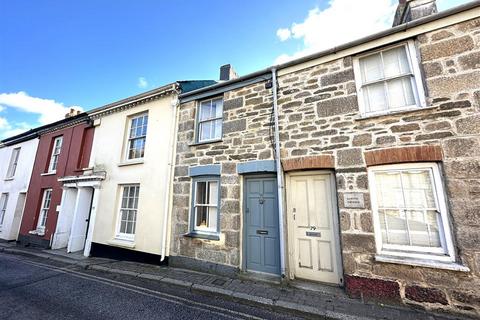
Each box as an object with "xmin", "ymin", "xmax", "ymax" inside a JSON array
[{"xmin": 0, "ymin": 0, "xmax": 480, "ymax": 316}]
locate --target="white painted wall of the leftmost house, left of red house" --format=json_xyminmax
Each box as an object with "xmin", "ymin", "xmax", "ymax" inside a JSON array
[{"xmin": 0, "ymin": 139, "xmax": 38, "ymax": 240}]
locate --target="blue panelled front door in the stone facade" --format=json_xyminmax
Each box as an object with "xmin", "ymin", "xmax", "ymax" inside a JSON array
[{"xmin": 245, "ymin": 178, "xmax": 280, "ymax": 274}]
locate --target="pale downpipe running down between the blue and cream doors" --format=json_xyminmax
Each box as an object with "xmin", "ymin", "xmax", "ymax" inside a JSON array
[{"xmin": 272, "ymin": 68, "xmax": 285, "ymax": 278}]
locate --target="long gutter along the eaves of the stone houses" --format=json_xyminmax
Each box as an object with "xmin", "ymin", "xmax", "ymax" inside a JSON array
[{"xmin": 179, "ymin": 0, "xmax": 480, "ymax": 100}]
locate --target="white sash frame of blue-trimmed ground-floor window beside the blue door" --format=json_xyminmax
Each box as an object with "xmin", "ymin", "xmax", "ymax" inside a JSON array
[{"xmin": 190, "ymin": 176, "xmax": 221, "ymax": 235}]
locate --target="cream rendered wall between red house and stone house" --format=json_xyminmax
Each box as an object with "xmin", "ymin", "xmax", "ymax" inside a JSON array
[{"xmin": 90, "ymin": 95, "xmax": 174, "ymax": 254}]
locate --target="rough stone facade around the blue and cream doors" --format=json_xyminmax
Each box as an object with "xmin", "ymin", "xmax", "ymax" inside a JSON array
[{"xmin": 171, "ymin": 18, "xmax": 480, "ymax": 316}]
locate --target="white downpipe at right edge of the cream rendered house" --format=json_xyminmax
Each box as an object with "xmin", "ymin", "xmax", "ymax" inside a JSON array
[{"xmin": 160, "ymin": 90, "xmax": 180, "ymax": 261}]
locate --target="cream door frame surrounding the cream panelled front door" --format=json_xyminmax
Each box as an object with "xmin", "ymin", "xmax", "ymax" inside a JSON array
[{"xmin": 285, "ymin": 170, "xmax": 344, "ymax": 285}]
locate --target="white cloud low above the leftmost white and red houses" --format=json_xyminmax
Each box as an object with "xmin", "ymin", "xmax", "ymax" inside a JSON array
[{"xmin": 0, "ymin": 91, "xmax": 82, "ymax": 124}]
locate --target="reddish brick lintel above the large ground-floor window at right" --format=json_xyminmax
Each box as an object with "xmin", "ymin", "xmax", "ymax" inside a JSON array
[{"xmin": 365, "ymin": 145, "xmax": 443, "ymax": 166}]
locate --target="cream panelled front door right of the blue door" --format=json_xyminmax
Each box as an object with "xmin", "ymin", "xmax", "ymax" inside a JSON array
[{"xmin": 287, "ymin": 172, "xmax": 342, "ymax": 284}]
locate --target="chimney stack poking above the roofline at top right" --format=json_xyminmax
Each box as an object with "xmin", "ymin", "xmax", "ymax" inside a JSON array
[{"xmin": 392, "ymin": 0, "xmax": 438, "ymax": 27}]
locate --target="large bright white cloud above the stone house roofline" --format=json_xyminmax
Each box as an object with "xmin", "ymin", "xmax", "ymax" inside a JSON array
[{"xmin": 275, "ymin": 0, "xmax": 398, "ymax": 63}]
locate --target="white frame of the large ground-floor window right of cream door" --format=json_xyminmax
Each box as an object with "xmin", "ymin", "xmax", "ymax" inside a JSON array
[{"xmin": 368, "ymin": 162, "xmax": 455, "ymax": 263}]
